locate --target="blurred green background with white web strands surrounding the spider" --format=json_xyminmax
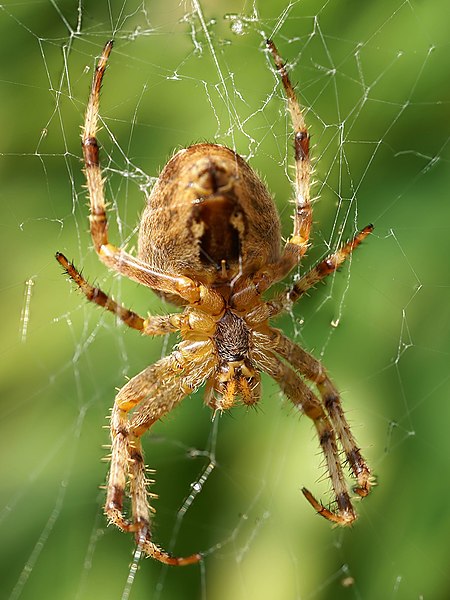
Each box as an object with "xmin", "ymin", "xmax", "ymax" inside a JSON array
[{"xmin": 0, "ymin": 0, "xmax": 450, "ymax": 600}]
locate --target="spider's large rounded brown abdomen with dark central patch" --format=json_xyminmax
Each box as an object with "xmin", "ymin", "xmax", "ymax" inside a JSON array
[{"xmin": 139, "ymin": 144, "xmax": 281, "ymax": 285}]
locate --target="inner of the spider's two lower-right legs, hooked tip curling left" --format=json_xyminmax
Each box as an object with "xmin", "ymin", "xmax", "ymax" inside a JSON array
[{"xmin": 257, "ymin": 349, "xmax": 356, "ymax": 525}]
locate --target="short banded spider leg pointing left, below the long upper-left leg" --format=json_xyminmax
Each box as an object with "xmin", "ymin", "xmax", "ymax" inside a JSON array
[{"xmin": 56, "ymin": 252, "xmax": 182, "ymax": 335}]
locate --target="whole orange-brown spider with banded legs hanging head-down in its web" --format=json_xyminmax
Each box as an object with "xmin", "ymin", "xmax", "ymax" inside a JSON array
[{"xmin": 56, "ymin": 40, "xmax": 373, "ymax": 565}]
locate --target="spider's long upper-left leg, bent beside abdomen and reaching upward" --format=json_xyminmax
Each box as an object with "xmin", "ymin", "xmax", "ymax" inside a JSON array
[{"xmin": 81, "ymin": 41, "xmax": 223, "ymax": 314}]
